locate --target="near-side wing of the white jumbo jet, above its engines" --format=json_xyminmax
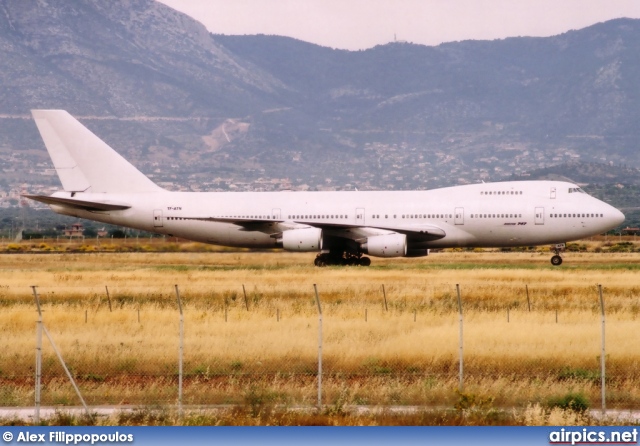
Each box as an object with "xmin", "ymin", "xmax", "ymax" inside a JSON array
[{"xmin": 187, "ymin": 217, "xmax": 446, "ymax": 241}]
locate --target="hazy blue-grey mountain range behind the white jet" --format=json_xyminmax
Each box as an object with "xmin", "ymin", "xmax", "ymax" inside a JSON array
[{"xmin": 0, "ymin": 0, "xmax": 640, "ymax": 194}]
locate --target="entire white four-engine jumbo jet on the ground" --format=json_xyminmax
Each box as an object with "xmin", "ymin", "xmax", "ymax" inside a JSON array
[{"xmin": 25, "ymin": 110, "xmax": 625, "ymax": 266}]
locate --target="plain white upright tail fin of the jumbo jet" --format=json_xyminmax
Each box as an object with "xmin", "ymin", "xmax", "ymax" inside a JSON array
[{"xmin": 31, "ymin": 110, "xmax": 162, "ymax": 193}]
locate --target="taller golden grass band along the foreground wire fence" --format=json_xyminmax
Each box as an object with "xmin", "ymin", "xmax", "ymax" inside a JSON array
[{"xmin": 0, "ymin": 285, "xmax": 640, "ymax": 408}]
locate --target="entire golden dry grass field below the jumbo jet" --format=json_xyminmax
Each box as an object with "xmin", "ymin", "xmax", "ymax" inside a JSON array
[{"xmin": 0, "ymin": 241, "xmax": 640, "ymax": 424}]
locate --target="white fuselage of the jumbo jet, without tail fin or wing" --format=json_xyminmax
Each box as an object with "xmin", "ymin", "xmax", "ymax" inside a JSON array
[{"xmin": 47, "ymin": 181, "xmax": 624, "ymax": 248}]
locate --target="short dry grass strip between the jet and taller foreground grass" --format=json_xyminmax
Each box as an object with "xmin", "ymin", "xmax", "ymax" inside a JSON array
[{"xmin": 0, "ymin": 253, "xmax": 640, "ymax": 308}]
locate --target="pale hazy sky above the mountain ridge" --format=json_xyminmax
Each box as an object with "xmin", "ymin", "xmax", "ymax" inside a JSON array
[{"xmin": 160, "ymin": 0, "xmax": 640, "ymax": 50}]
